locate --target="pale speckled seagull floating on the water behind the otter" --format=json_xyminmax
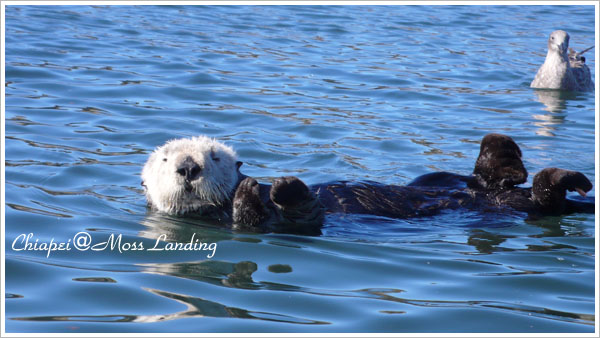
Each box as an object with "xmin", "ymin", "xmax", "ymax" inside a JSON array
[{"xmin": 531, "ymin": 30, "xmax": 594, "ymax": 92}]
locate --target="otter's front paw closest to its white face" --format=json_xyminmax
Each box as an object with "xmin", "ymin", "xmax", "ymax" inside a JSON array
[{"xmin": 233, "ymin": 177, "xmax": 269, "ymax": 227}]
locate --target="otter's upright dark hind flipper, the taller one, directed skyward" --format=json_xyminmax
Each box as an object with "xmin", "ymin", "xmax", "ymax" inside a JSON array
[{"xmin": 473, "ymin": 134, "xmax": 527, "ymax": 189}]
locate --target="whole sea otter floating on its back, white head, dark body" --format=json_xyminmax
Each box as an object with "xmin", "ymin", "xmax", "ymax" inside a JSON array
[{"xmin": 142, "ymin": 134, "xmax": 594, "ymax": 234}]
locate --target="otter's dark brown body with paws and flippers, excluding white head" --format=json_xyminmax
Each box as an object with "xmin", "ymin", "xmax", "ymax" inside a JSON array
[{"xmin": 233, "ymin": 134, "xmax": 594, "ymax": 234}]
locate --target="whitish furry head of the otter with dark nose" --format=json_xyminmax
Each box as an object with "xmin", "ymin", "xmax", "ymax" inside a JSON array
[{"xmin": 142, "ymin": 136, "xmax": 239, "ymax": 214}]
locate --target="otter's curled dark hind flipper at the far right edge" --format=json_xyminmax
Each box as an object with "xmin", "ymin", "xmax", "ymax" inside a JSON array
[{"xmin": 531, "ymin": 168, "xmax": 592, "ymax": 214}]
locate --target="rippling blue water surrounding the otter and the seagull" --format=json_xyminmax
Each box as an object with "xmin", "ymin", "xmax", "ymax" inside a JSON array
[{"xmin": 3, "ymin": 6, "xmax": 597, "ymax": 333}]
